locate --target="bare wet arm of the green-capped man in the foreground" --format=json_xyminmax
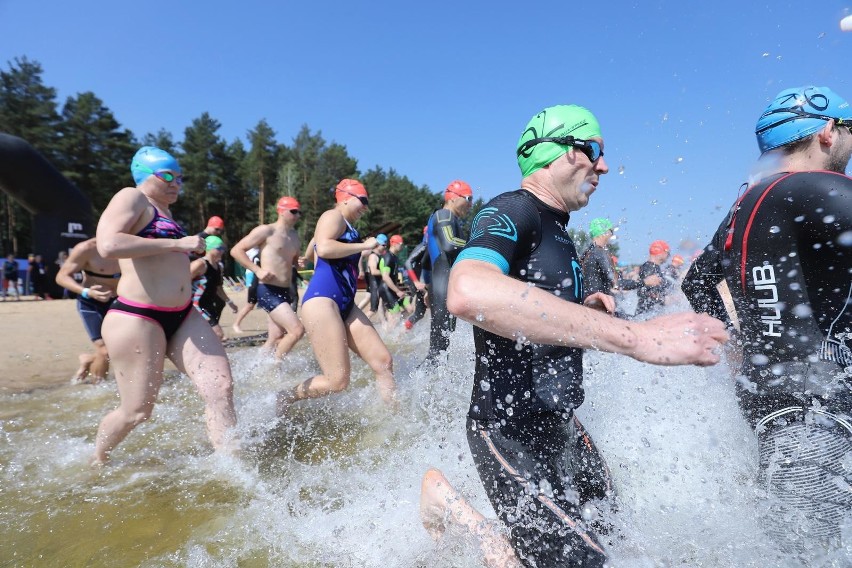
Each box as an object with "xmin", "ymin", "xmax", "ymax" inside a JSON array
[{"xmin": 447, "ymin": 259, "xmax": 727, "ymax": 365}]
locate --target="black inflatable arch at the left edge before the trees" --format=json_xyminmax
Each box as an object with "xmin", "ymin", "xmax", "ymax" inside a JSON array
[{"xmin": 0, "ymin": 132, "xmax": 95, "ymax": 262}]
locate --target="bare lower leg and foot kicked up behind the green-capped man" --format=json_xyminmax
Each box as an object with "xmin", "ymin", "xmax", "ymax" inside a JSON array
[{"xmin": 420, "ymin": 469, "xmax": 522, "ymax": 568}]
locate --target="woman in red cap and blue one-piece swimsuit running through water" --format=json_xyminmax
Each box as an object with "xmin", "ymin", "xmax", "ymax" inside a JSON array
[{"xmin": 277, "ymin": 179, "xmax": 396, "ymax": 416}]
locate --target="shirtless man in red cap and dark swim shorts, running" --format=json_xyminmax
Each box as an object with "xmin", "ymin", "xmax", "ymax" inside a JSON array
[{"xmin": 231, "ymin": 197, "xmax": 305, "ymax": 359}]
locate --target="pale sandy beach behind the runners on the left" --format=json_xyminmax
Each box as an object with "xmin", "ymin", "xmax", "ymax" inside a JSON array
[{"xmin": 0, "ymin": 291, "xmax": 266, "ymax": 393}]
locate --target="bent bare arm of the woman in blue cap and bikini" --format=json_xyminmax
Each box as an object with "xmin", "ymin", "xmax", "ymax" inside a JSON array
[{"xmin": 97, "ymin": 187, "xmax": 204, "ymax": 258}]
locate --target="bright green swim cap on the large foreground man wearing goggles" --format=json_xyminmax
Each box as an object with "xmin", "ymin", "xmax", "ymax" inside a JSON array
[{"xmin": 517, "ymin": 105, "xmax": 601, "ymax": 177}]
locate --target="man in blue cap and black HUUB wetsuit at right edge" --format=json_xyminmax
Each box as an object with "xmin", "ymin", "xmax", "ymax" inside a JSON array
[{"xmin": 682, "ymin": 86, "xmax": 852, "ymax": 552}]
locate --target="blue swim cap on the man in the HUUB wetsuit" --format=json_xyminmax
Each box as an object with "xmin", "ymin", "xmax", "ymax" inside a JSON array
[{"xmin": 754, "ymin": 85, "xmax": 852, "ymax": 153}]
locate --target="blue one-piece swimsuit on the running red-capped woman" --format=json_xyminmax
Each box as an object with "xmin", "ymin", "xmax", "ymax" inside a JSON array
[{"xmin": 303, "ymin": 221, "xmax": 363, "ymax": 321}]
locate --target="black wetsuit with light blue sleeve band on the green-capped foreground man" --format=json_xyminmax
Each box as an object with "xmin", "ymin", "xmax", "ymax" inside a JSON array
[{"xmin": 457, "ymin": 190, "xmax": 611, "ymax": 567}]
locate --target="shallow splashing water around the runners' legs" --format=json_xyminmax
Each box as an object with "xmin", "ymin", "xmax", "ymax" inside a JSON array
[{"xmin": 0, "ymin": 296, "xmax": 852, "ymax": 568}]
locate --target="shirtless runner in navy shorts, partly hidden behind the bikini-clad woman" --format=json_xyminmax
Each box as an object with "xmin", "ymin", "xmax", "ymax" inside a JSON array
[{"xmin": 56, "ymin": 238, "xmax": 121, "ymax": 384}]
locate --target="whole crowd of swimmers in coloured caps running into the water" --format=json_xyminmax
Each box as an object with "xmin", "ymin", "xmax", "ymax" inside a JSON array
[{"xmin": 25, "ymin": 82, "xmax": 852, "ymax": 567}]
